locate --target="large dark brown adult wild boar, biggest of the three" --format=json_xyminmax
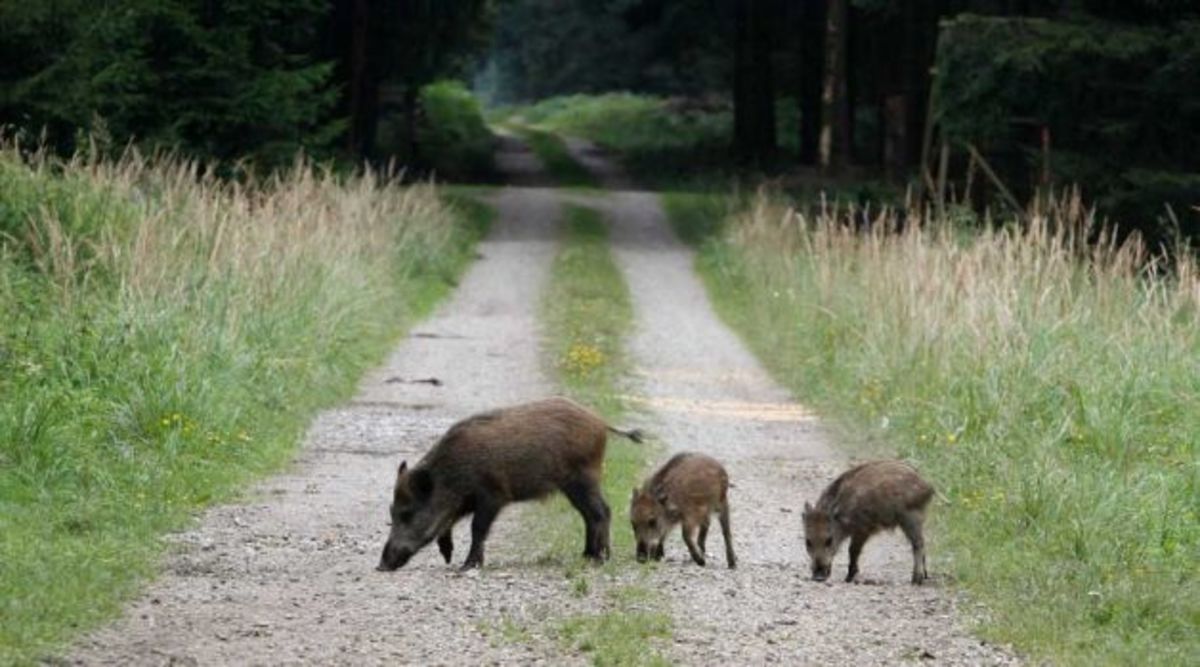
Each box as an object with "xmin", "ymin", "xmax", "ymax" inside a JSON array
[{"xmin": 378, "ymin": 398, "xmax": 642, "ymax": 571}]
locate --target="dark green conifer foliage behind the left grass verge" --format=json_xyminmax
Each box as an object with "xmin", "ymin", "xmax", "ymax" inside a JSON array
[{"xmin": 0, "ymin": 0, "xmax": 342, "ymax": 167}]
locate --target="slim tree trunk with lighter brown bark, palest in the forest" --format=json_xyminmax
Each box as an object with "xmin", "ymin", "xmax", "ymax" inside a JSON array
[{"xmin": 821, "ymin": 0, "xmax": 851, "ymax": 172}]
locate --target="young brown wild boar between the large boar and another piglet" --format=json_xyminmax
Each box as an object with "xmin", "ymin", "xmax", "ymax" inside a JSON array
[{"xmin": 629, "ymin": 452, "xmax": 738, "ymax": 567}]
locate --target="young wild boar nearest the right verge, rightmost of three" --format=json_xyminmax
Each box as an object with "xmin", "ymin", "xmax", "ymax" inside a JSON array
[{"xmin": 804, "ymin": 461, "xmax": 934, "ymax": 584}]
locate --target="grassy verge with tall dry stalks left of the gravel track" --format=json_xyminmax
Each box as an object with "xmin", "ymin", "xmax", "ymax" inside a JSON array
[{"xmin": 0, "ymin": 151, "xmax": 487, "ymax": 665}]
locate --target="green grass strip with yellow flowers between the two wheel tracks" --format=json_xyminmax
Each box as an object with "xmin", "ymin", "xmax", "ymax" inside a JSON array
[{"xmin": 538, "ymin": 206, "xmax": 671, "ymax": 665}]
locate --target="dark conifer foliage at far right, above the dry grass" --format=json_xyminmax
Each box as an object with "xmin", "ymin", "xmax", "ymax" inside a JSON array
[{"xmin": 935, "ymin": 16, "xmax": 1200, "ymax": 239}]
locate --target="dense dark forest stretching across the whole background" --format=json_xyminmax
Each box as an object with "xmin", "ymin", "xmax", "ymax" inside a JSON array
[{"xmin": 0, "ymin": 0, "xmax": 1200, "ymax": 234}]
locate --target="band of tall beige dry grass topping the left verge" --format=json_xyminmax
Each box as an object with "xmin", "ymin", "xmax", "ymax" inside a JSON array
[{"xmin": 12, "ymin": 149, "xmax": 454, "ymax": 299}]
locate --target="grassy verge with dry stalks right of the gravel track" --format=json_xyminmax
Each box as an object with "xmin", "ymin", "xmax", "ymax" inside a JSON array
[{"xmin": 665, "ymin": 190, "xmax": 1200, "ymax": 665}]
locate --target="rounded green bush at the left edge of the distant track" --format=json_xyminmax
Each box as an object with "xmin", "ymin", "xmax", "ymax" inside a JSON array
[{"xmin": 419, "ymin": 80, "xmax": 496, "ymax": 181}]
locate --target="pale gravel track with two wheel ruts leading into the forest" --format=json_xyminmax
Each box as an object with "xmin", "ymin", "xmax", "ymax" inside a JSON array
[{"xmin": 70, "ymin": 134, "xmax": 1012, "ymax": 665}]
